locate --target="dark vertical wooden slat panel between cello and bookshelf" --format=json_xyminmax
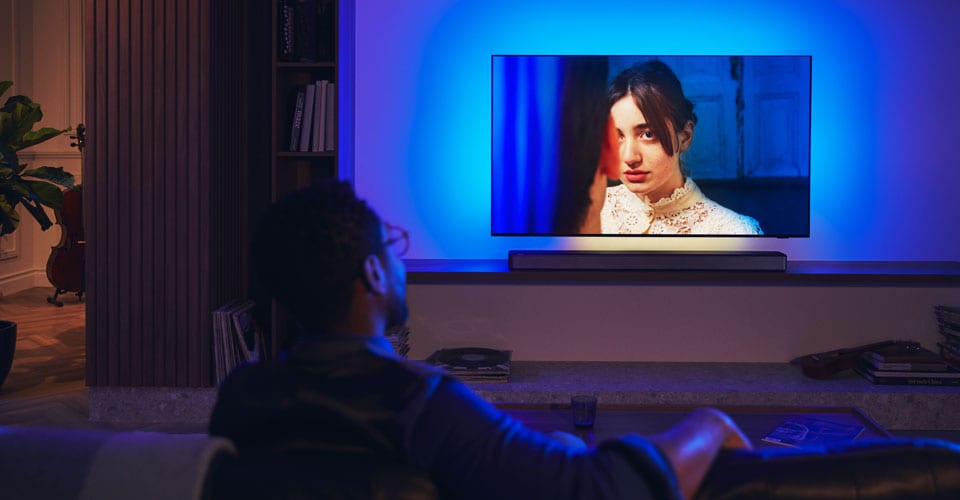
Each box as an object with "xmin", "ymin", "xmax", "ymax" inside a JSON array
[{"xmin": 84, "ymin": 0, "xmax": 247, "ymax": 387}]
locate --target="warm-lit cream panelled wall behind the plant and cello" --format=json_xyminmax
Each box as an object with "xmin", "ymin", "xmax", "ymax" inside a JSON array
[{"xmin": 0, "ymin": 0, "xmax": 83, "ymax": 295}]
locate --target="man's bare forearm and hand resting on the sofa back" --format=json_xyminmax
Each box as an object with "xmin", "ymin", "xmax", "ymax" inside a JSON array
[{"xmin": 649, "ymin": 408, "xmax": 752, "ymax": 498}]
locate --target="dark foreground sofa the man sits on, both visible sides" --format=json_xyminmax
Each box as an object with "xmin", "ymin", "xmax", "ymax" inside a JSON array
[{"xmin": 0, "ymin": 426, "xmax": 960, "ymax": 500}]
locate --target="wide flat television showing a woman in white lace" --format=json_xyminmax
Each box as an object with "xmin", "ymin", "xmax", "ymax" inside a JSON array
[{"xmin": 491, "ymin": 55, "xmax": 812, "ymax": 237}]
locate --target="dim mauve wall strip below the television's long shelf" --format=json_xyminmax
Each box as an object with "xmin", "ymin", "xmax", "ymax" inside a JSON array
[{"xmin": 408, "ymin": 283, "xmax": 960, "ymax": 362}]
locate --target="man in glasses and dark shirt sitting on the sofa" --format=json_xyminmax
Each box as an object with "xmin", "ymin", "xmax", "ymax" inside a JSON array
[{"xmin": 210, "ymin": 181, "xmax": 750, "ymax": 499}]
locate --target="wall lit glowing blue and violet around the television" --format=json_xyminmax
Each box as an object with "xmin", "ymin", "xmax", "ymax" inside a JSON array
[{"xmin": 354, "ymin": 0, "xmax": 960, "ymax": 260}]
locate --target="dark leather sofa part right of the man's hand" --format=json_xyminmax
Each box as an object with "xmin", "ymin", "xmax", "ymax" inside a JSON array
[{"xmin": 697, "ymin": 439, "xmax": 960, "ymax": 500}]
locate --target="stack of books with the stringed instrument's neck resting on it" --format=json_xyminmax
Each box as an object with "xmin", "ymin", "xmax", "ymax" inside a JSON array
[{"xmin": 856, "ymin": 343, "xmax": 960, "ymax": 385}]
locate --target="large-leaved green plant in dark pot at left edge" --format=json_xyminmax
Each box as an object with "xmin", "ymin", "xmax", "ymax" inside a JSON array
[{"xmin": 0, "ymin": 81, "xmax": 73, "ymax": 387}]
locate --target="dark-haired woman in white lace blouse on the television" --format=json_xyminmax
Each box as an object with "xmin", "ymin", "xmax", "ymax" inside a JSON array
[{"xmin": 600, "ymin": 60, "xmax": 763, "ymax": 235}]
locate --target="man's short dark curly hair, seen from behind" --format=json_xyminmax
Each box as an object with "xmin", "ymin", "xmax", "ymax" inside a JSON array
[{"xmin": 252, "ymin": 180, "xmax": 383, "ymax": 332}]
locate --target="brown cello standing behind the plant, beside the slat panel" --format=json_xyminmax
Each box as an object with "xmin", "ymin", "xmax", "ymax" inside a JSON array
[{"xmin": 47, "ymin": 123, "xmax": 86, "ymax": 307}]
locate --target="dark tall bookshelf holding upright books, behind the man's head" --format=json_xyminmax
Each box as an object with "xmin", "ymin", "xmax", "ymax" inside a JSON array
[{"xmin": 268, "ymin": 0, "xmax": 344, "ymax": 355}]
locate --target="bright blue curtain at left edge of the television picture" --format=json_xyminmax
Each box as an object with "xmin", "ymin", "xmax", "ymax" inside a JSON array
[{"xmin": 491, "ymin": 56, "xmax": 563, "ymax": 234}]
